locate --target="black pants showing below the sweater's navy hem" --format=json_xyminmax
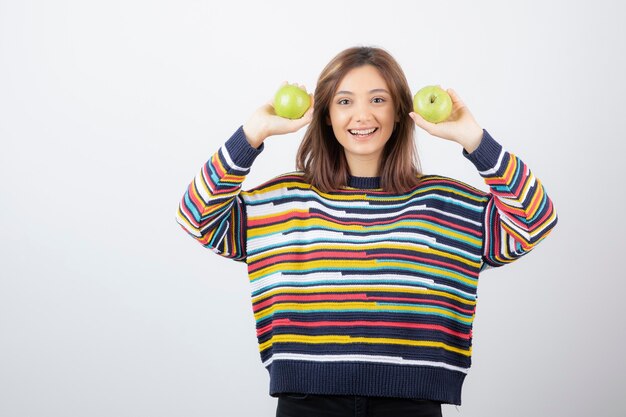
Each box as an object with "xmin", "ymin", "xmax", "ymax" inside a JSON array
[{"xmin": 276, "ymin": 394, "xmax": 441, "ymax": 417}]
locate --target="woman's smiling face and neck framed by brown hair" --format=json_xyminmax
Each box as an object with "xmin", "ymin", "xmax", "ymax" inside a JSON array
[{"xmin": 329, "ymin": 65, "xmax": 396, "ymax": 177}]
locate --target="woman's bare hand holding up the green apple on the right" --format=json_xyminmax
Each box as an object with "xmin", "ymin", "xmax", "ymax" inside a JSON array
[{"xmin": 409, "ymin": 88, "xmax": 483, "ymax": 153}]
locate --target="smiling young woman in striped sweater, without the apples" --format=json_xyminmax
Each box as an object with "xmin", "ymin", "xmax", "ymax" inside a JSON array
[{"xmin": 177, "ymin": 47, "xmax": 557, "ymax": 417}]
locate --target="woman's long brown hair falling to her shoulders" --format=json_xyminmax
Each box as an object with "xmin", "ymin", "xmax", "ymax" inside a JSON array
[{"xmin": 296, "ymin": 46, "xmax": 421, "ymax": 193}]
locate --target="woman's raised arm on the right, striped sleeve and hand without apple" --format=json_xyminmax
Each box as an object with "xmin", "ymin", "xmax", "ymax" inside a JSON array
[{"xmin": 410, "ymin": 89, "xmax": 557, "ymax": 266}]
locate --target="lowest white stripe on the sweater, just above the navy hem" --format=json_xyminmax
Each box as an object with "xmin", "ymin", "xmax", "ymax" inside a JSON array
[{"xmin": 263, "ymin": 353, "xmax": 468, "ymax": 374}]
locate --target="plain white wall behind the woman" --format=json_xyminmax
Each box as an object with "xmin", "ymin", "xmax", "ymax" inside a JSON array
[{"xmin": 0, "ymin": 0, "xmax": 626, "ymax": 417}]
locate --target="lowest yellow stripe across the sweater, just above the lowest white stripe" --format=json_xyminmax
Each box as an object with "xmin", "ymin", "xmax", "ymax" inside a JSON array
[{"xmin": 259, "ymin": 334, "xmax": 472, "ymax": 357}]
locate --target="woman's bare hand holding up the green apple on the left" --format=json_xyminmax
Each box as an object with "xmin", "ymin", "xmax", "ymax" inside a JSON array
[{"xmin": 243, "ymin": 83, "xmax": 314, "ymax": 148}]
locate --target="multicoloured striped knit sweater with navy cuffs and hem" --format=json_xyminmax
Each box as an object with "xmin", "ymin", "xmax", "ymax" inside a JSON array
[{"xmin": 177, "ymin": 128, "xmax": 557, "ymax": 404}]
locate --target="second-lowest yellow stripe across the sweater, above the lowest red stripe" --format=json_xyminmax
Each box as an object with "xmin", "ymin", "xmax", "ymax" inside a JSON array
[{"xmin": 254, "ymin": 301, "xmax": 473, "ymax": 324}]
